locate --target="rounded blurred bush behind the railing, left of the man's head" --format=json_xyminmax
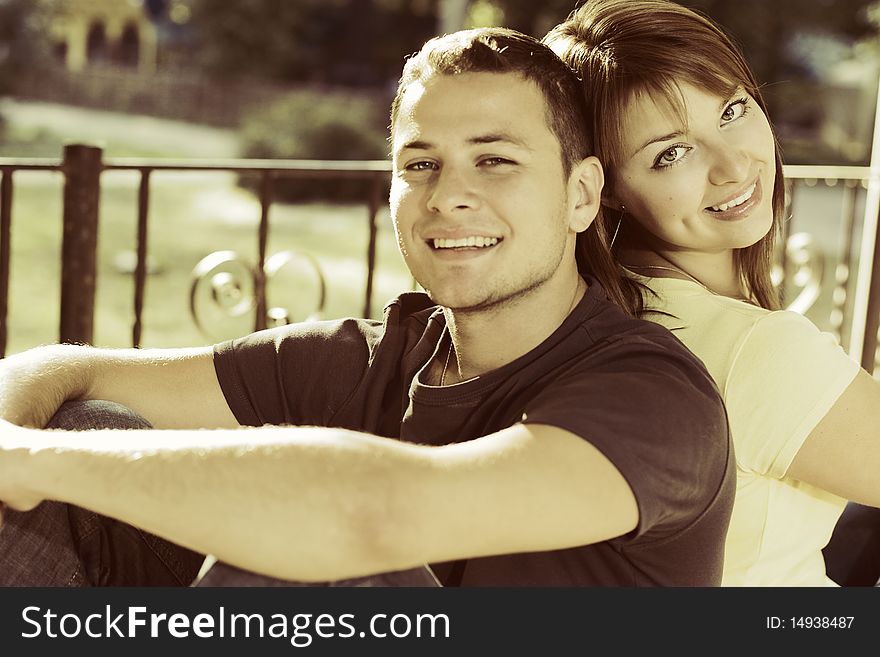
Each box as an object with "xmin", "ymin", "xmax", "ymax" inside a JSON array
[{"xmin": 241, "ymin": 91, "xmax": 388, "ymax": 201}]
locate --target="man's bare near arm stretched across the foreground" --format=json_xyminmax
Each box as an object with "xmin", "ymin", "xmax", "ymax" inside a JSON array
[{"xmin": 0, "ymin": 423, "xmax": 638, "ymax": 581}]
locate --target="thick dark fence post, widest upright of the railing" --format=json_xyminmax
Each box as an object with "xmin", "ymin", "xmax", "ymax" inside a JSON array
[{"xmin": 59, "ymin": 144, "xmax": 103, "ymax": 344}]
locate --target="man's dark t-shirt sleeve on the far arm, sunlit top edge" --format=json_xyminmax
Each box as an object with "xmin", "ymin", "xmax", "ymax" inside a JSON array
[{"xmin": 214, "ymin": 320, "xmax": 379, "ymax": 426}]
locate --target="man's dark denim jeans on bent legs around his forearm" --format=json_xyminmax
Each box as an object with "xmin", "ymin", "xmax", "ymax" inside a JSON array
[{"xmin": 0, "ymin": 401, "xmax": 438, "ymax": 586}]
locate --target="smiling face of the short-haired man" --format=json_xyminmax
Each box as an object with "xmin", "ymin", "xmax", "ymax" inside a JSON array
[{"xmin": 391, "ymin": 73, "xmax": 577, "ymax": 310}]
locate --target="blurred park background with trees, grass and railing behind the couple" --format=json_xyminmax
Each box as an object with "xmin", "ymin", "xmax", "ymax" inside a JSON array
[{"xmin": 0, "ymin": 0, "xmax": 880, "ymax": 364}]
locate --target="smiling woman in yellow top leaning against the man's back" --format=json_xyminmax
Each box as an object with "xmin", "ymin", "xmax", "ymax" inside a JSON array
[{"xmin": 544, "ymin": 0, "xmax": 880, "ymax": 586}]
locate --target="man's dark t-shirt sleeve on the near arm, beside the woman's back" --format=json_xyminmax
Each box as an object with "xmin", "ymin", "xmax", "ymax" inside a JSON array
[{"xmin": 523, "ymin": 335, "xmax": 731, "ymax": 537}]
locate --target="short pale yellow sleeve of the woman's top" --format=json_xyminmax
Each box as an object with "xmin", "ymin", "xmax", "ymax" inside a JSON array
[{"xmin": 724, "ymin": 311, "xmax": 859, "ymax": 478}]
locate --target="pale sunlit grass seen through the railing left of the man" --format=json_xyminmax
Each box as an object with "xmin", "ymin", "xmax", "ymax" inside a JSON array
[{"xmin": 0, "ymin": 114, "xmax": 413, "ymax": 354}]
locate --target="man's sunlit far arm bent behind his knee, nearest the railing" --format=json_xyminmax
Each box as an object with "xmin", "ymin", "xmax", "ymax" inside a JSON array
[{"xmin": 0, "ymin": 345, "xmax": 238, "ymax": 429}]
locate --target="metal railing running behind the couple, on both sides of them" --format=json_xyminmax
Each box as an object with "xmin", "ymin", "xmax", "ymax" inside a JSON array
[{"xmin": 0, "ymin": 145, "xmax": 880, "ymax": 372}]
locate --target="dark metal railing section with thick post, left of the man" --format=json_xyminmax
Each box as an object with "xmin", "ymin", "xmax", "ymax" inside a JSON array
[{"xmin": 0, "ymin": 144, "xmax": 390, "ymax": 357}]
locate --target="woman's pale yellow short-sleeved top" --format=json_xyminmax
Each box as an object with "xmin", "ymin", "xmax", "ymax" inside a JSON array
[{"xmin": 632, "ymin": 274, "xmax": 859, "ymax": 586}]
